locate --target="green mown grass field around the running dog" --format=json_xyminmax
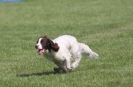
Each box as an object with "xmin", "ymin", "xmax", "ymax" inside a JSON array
[{"xmin": 0, "ymin": 0, "xmax": 133, "ymax": 87}]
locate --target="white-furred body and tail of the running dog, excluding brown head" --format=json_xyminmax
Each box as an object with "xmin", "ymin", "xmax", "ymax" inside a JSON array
[{"xmin": 45, "ymin": 35, "xmax": 98, "ymax": 70}]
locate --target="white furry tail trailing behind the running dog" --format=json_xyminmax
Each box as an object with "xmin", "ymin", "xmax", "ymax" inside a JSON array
[{"xmin": 79, "ymin": 43, "xmax": 99, "ymax": 59}]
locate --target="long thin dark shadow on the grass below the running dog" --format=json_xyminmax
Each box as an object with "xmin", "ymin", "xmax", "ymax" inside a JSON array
[{"xmin": 16, "ymin": 71, "xmax": 58, "ymax": 77}]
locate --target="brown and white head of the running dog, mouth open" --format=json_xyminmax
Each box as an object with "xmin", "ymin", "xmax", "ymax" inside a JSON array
[{"xmin": 35, "ymin": 36, "xmax": 59, "ymax": 55}]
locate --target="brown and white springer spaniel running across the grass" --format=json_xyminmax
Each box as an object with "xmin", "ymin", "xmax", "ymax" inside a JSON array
[{"xmin": 35, "ymin": 35, "xmax": 98, "ymax": 72}]
